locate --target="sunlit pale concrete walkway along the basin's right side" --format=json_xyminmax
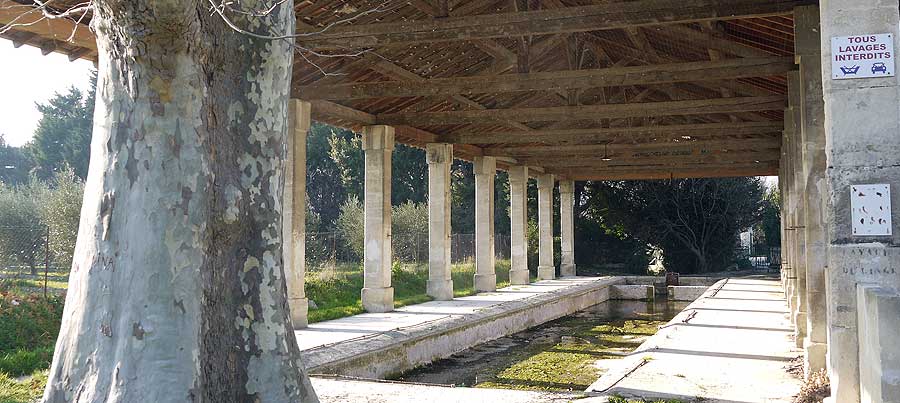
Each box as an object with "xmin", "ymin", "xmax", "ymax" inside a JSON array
[{"xmin": 585, "ymin": 279, "xmax": 802, "ymax": 403}]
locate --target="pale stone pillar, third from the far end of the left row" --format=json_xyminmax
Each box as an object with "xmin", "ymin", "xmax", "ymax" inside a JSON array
[{"xmin": 508, "ymin": 166, "xmax": 531, "ymax": 285}]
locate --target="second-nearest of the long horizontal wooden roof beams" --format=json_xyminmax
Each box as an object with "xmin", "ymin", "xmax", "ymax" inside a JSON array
[{"xmin": 298, "ymin": 57, "xmax": 794, "ymax": 100}]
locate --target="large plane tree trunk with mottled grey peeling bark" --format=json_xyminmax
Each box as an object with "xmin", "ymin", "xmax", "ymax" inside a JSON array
[{"xmin": 44, "ymin": 0, "xmax": 316, "ymax": 402}]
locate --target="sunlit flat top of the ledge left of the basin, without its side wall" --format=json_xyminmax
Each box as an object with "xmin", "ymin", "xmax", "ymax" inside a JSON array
[{"xmin": 295, "ymin": 277, "xmax": 599, "ymax": 350}]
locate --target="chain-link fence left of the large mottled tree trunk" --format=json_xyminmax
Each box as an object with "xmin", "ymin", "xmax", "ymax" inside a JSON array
[{"xmin": 0, "ymin": 225, "xmax": 72, "ymax": 295}]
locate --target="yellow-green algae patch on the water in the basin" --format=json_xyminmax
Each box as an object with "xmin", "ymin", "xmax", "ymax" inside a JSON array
[{"xmin": 476, "ymin": 318, "xmax": 665, "ymax": 391}]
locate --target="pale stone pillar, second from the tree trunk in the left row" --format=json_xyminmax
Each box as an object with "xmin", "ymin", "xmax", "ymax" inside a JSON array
[{"xmin": 362, "ymin": 125, "xmax": 394, "ymax": 312}]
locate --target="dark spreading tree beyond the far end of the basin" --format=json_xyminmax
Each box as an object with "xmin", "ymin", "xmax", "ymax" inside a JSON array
[{"xmin": 588, "ymin": 178, "xmax": 763, "ymax": 273}]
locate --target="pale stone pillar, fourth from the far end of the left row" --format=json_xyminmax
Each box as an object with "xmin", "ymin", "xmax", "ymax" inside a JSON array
[{"xmin": 474, "ymin": 157, "xmax": 497, "ymax": 291}]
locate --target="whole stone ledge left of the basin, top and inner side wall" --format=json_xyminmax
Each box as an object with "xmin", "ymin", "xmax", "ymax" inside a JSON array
[{"xmin": 296, "ymin": 277, "xmax": 625, "ymax": 379}]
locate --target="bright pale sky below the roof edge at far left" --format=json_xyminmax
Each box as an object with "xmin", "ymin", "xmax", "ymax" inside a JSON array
[{"xmin": 0, "ymin": 39, "xmax": 94, "ymax": 146}]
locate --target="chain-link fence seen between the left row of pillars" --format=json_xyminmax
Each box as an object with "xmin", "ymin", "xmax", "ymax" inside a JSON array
[{"xmin": 306, "ymin": 231, "xmax": 510, "ymax": 272}]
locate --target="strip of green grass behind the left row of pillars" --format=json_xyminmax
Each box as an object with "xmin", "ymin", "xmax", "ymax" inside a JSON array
[{"xmin": 306, "ymin": 260, "xmax": 509, "ymax": 323}]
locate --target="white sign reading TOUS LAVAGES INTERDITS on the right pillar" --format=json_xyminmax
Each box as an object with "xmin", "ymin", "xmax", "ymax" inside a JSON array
[{"xmin": 831, "ymin": 34, "xmax": 894, "ymax": 80}]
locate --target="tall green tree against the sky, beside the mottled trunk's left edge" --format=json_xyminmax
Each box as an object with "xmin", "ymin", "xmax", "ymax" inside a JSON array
[{"xmin": 26, "ymin": 72, "xmax": 97, "ymax": 179}]
